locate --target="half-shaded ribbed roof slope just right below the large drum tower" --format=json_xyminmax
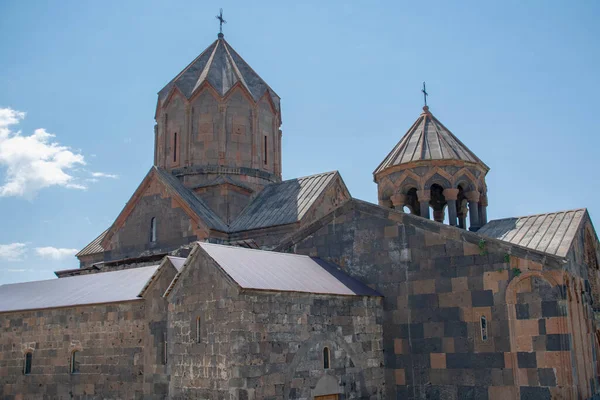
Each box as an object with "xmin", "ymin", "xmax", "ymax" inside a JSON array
[{"xmin": 231, "ymin": 171, "xmax": 338, "ymax": 232}]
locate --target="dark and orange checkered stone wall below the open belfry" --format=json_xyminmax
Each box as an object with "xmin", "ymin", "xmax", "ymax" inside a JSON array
[{"xmin": 279, "ymin": 200, "xmax": 593, "ymax": 399}]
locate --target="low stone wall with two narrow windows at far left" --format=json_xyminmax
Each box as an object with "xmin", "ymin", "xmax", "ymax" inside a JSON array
[{"xmin": 0, "ymin": 301, "xmax": 145, "ymax": 400}]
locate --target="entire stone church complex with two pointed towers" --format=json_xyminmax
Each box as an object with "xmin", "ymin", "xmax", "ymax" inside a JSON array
[{"xmin": 0, "ymin": 28, "xmax": 600, "ymax": 400}]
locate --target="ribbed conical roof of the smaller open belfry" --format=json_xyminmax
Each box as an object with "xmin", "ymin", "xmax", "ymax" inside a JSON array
[{"xmin": 373, "ymin": 107, "xmax": 488, "ymax": 174}]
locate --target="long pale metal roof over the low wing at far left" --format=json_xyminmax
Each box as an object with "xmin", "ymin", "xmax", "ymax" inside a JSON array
[{"xmin": 0, "ymin": 265, "xmax": 158, "ymax": 312}]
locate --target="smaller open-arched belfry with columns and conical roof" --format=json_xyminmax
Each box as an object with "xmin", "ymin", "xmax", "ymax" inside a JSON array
[{"xmin": 373, "ymin": 106, "xmax": 489, "ymax": 231}]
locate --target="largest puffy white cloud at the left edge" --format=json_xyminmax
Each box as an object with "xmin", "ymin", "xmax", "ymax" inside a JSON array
[{"xmin": 0, "ymin": 108, "xmax": 85, "ymax": 199}]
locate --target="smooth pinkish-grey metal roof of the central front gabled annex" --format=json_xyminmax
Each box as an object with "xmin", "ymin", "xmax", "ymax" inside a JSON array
[{"xmin": 199, "ymin": 243, "xmax": 380, "ymax": 296}]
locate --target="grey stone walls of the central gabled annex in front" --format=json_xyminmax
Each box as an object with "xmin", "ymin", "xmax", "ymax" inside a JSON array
[{"xmin": 169, "ymin": 248, "xmax": 383, "ymax": 399}]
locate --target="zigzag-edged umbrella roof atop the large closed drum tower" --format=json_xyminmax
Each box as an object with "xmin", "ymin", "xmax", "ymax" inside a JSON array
[{"xmin": 158, "ymin": 38, "xmax": 280, "ymax": 110}]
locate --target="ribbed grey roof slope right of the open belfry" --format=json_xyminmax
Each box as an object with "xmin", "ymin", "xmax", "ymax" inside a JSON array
[{"xmin": 477, "ymin": 209, "xmax": 586, "ymax": 257}]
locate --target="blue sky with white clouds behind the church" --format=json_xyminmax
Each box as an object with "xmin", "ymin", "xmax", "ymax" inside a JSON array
[{"xmin": 0, "ymin": 0, "xmax": 600, "ymax": 283}]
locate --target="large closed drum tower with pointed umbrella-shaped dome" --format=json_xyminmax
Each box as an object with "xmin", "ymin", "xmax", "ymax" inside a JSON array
[{"xmin": 154, "ymin": 29, "xmax": 282, "ymax": 223}]
